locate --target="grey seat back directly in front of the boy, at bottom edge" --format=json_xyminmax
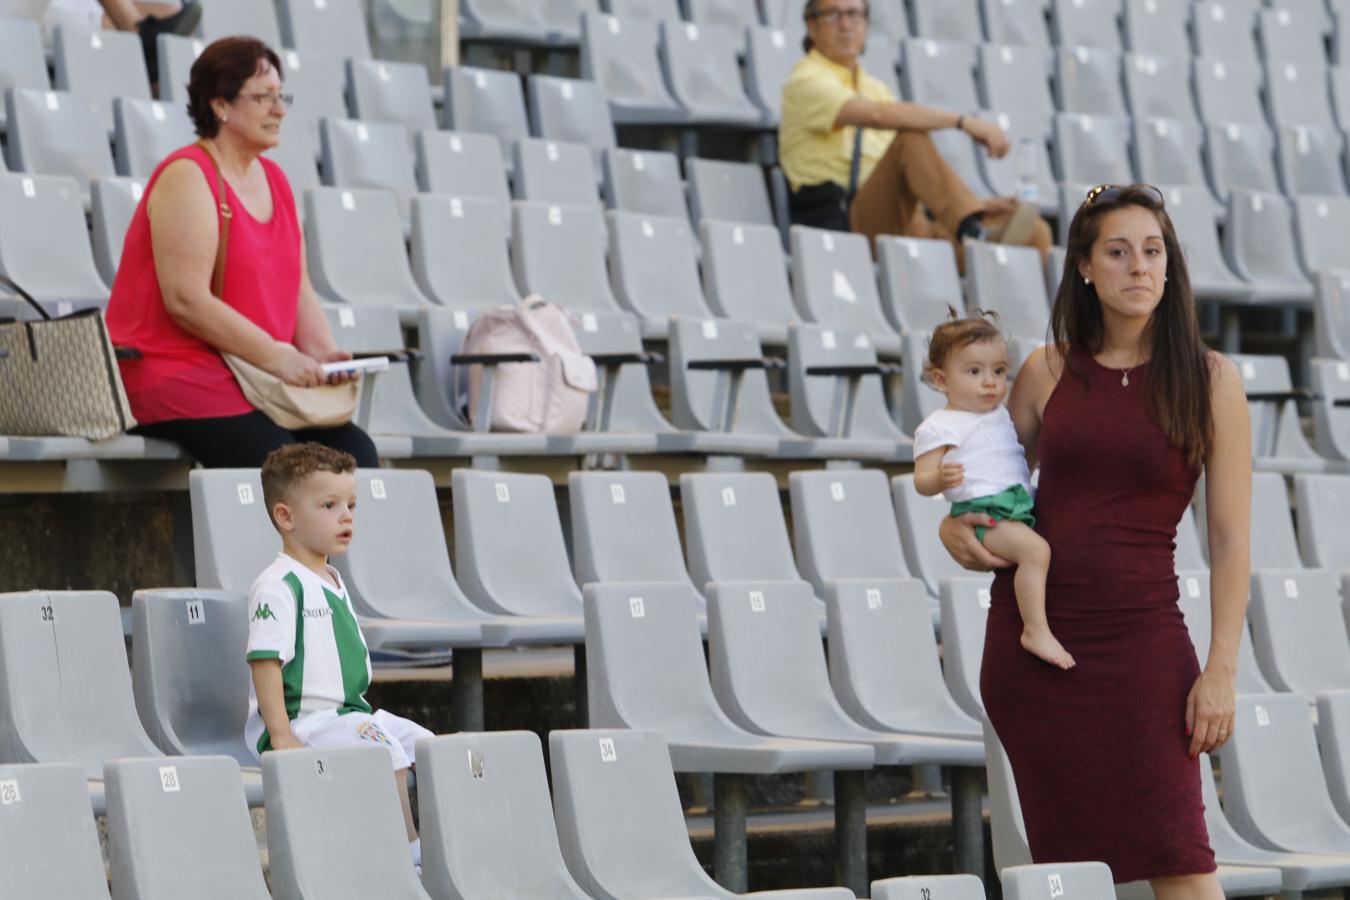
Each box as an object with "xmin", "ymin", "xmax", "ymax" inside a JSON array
[{"xmin": 262, "ymin": 750, "xmax": 429, "ymax": 900}]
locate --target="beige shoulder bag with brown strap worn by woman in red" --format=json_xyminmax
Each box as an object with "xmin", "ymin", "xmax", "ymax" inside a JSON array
[{"xmin": 197, "ymin": 140, "xmax": 359, "ymax": 430}]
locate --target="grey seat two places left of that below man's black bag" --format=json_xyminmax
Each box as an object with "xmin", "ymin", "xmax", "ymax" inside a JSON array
[{"xmin": 605, "ymin": 209, "xmax": 713, "ymax": 330}]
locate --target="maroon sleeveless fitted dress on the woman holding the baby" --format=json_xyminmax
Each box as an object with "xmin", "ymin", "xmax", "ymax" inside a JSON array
[{"xmin": 980, "ymin": 351, "xmax": 1215, "ymax": 882}]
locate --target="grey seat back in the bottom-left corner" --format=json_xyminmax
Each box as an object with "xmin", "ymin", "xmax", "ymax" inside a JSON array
[{"xmin": 0, "ymin": 764, "xmax": 108, "ymax": 900}]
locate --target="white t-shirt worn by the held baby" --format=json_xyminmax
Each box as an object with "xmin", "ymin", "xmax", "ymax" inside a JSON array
[{"xmin": 914, "ymin": 403, "xmax": 1033, "ymax": 503}]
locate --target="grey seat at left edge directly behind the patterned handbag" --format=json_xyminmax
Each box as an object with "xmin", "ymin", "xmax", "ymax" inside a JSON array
[{"xmin": 0, "ymin": 172, "xmax": 108, "ymax": 318}]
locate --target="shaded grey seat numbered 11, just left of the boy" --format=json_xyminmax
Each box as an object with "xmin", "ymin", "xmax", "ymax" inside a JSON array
[{"xmin": 131, "ymin": 588, "xmax": 258, "ymax": 766}]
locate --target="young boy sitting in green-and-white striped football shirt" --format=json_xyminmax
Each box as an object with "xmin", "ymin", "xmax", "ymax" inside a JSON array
[{"xmin": 244, "ymin": 444, "xmax": 432, "ymax": 866}]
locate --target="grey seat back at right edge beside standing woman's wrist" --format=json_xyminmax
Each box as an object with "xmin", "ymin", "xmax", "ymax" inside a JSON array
[{"xmin": 1250, "ymin": 569, "xmax": 1350, "ymax": 696}]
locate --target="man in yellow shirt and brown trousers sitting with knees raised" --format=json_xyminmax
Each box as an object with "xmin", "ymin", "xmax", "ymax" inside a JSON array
[{"xmin": 778, "ymin": 0, "xmax": 1052, "ymax": 262}]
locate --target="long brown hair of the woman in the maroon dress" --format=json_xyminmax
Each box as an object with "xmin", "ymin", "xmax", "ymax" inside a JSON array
[{"xmin": 1050, "ymin": 185, "xmax": 1214, "ymax": 468}]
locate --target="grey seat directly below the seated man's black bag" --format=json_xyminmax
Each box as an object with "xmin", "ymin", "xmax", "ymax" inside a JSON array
[{"xmin": 790, "ymin": 225, "xmax": 899, "ymax": 356}]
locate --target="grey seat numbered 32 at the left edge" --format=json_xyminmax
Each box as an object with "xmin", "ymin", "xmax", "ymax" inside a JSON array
[{"xmin": 0, "ymin": 591, "xmax": 162, "ymax": 779}]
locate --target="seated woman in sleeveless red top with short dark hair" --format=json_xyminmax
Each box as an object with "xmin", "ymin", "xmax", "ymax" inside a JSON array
[{"xmin": 108, "ymin": 38, "xmax": 379, "ymax": 467}]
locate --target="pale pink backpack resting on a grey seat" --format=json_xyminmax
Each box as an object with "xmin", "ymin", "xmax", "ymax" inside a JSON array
[{"xmin": 456, "ymin": 294, "xmax": 597, "ymax": 434}]
